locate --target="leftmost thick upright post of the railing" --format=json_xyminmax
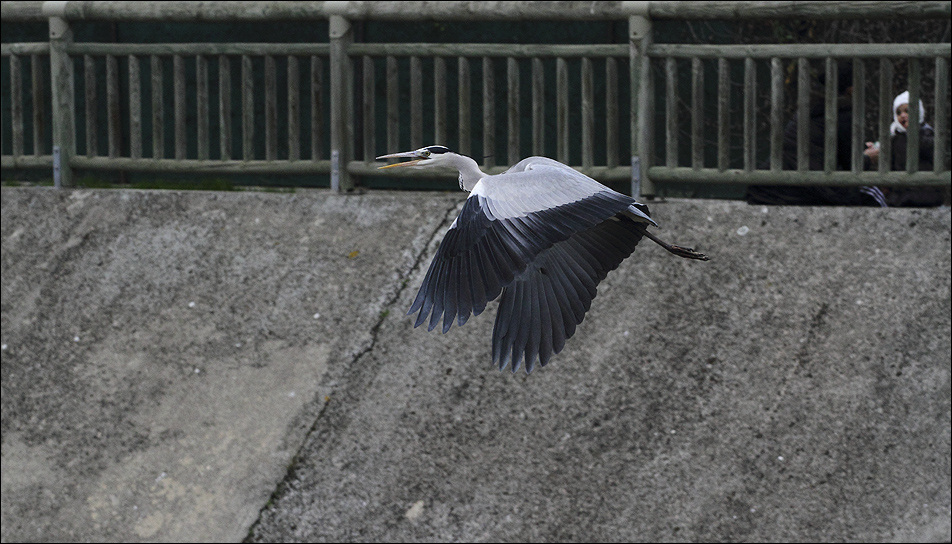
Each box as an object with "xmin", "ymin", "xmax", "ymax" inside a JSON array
[{"xmin": 43, "ymin": 2, "xmax": 76, "ymax": 187}]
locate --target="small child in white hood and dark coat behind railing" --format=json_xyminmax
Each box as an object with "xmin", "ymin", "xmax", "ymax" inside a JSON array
[{"xmin": 863, "ymin": 91, "xmax": 942, "ymax": 206}]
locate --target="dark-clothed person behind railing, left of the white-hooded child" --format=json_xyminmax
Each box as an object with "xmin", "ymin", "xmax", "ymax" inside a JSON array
[{"xmin": 747, "ymin": 62, "xmax": 886, "ymax": 207}]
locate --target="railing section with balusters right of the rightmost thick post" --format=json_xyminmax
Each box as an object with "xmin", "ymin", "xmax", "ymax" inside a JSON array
[{"xmin": 648, "ymin": 44, "xmax": 952, "ymax": 189}]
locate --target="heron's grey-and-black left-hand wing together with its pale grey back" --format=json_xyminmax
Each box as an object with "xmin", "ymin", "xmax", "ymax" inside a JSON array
[{"xmin": 407, "ymin": 164, "xmax": 650, "ymax": 332}]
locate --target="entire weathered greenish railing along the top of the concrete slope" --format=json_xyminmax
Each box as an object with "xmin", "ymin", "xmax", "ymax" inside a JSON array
[{"xmin": 0, "ymin": 2, "xmax": 952, "ymax": 195}]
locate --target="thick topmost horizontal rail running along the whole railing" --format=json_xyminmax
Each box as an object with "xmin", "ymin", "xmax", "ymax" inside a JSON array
[{"xmin": 0, "ymin": 0, "xmax": 952, "ymax": 22}]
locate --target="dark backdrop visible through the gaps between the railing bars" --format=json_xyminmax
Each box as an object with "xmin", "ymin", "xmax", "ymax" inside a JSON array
[{"xmin": 0, "ymin": 2, "xmax": 949, "ymax": 198}]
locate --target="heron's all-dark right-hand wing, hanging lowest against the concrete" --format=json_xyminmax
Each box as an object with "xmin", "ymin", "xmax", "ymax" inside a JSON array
[{"xmin": 493, "ymin": 215, "xmax": 644, "ymax": 373}]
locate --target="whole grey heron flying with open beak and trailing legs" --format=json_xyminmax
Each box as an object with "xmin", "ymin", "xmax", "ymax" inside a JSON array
[{"xmin": 377, "ymin": 145, "xmax": 708, "ymax": 373}]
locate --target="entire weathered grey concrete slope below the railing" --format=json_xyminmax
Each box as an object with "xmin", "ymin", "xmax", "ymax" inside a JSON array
[{"xmin": 2, "ymin": 189, "xmax": 952, "ymax": 541}]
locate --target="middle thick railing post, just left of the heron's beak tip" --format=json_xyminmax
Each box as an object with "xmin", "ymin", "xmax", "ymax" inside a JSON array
[{"xmin": 330, "ymin": 15, "xmax": 354, "ymax": 191}]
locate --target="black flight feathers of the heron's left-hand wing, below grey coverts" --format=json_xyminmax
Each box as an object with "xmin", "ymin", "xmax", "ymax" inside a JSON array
[{"xmin": 407, "ymin": 188, "xmax": 634, "ymax": 336}]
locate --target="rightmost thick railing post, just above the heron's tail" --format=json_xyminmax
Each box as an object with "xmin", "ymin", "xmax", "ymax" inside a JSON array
[{"xmin": 625, "ymin": 2, "xmax": 655, "ymax": 198}]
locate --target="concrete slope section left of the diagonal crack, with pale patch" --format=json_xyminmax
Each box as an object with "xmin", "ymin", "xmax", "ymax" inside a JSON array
[{"xmin": 2, "ymin": 189, "xmax": 458, "ymax": 541}]
